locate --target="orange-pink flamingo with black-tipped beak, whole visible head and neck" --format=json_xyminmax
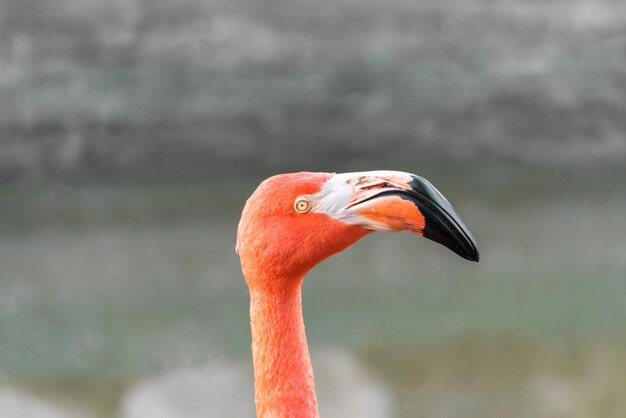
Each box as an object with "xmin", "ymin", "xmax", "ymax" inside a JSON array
[{"xmin": 236, "ymin": 171, "xmax": 479, "ymax": 418}]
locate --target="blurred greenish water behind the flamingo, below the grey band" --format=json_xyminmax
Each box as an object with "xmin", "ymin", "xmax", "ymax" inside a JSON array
[{"xmin": 0, "ymin": 160, "xmax": 626, "ymax": 417}]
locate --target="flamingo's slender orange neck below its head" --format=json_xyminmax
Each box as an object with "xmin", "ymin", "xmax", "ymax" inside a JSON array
[{"xmin": 250, "ymin": 278, "xmax": 319, "ymax": 418}]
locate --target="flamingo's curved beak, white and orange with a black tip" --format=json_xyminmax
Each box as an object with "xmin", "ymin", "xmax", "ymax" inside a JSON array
[{"xmin": 326, "ymin": 171, "xmax": 479, "ymax": 262}]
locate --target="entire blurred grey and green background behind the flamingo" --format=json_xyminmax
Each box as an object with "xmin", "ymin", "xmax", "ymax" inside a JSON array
[{"xmin": 0, "ymin": 0, "xmax": 626, "ymax": 418}]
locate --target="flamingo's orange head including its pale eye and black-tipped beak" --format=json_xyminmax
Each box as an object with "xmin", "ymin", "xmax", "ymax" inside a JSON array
[{"xmin": 237, "ymin": 171, "xmax": 479, "ymax": 286}]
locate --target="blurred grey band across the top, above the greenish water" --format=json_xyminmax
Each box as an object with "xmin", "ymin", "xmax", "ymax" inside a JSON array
[{"xmin": 0, "ymin": 0, "xmax": 626, "ymax": 183}]
